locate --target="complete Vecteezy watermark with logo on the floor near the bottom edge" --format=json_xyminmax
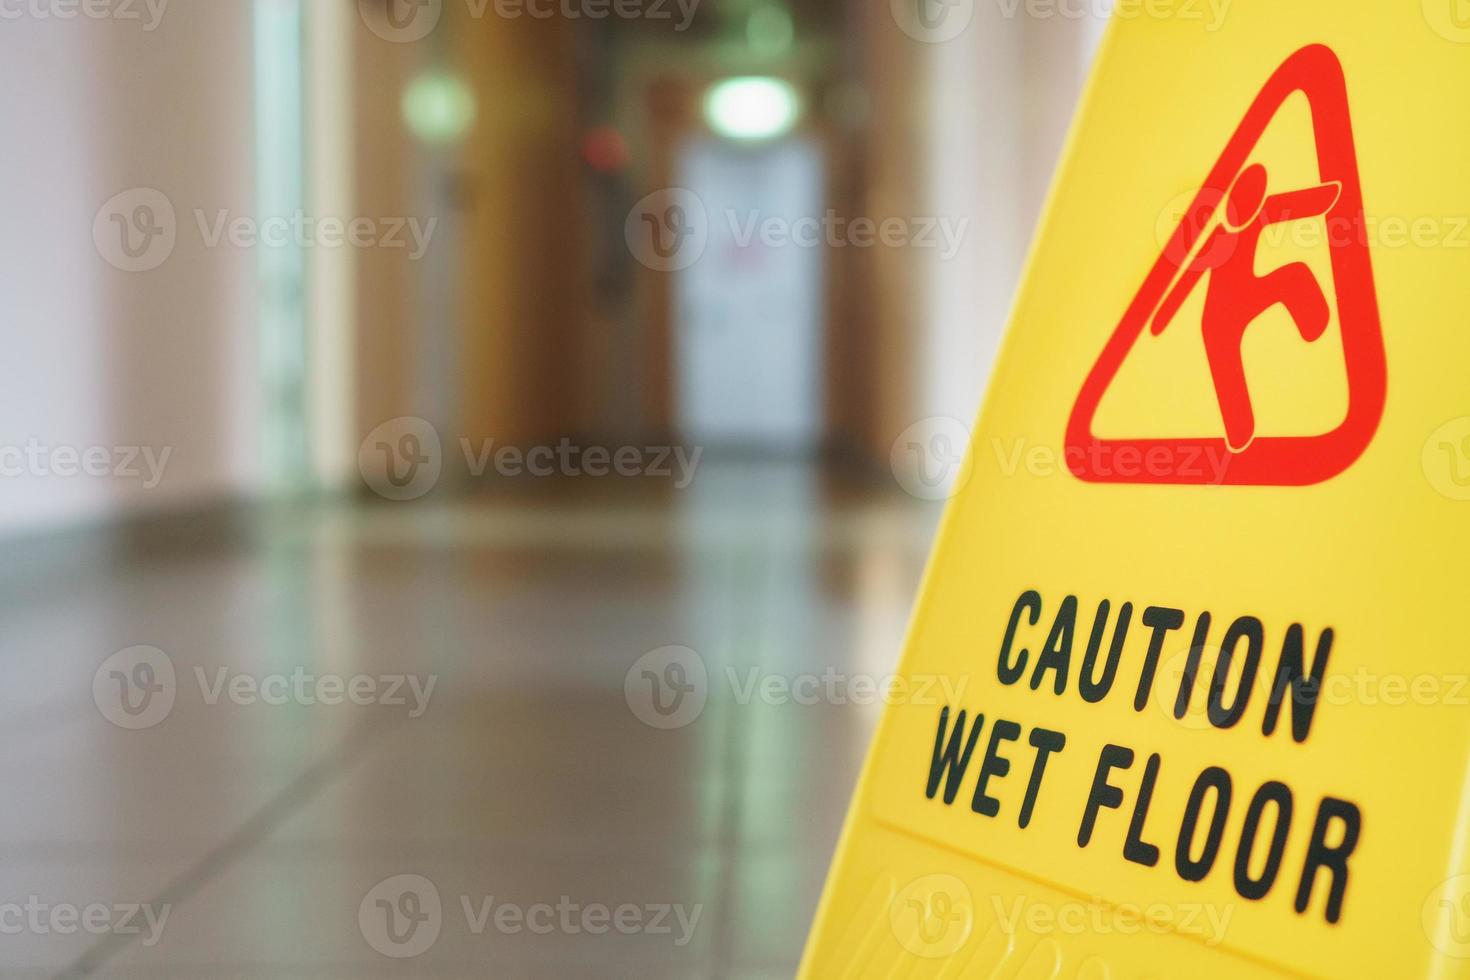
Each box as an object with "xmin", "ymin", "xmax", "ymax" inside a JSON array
[{"xmin": 357, "ymin": 874, "xmax": 704, "ymax": 959}]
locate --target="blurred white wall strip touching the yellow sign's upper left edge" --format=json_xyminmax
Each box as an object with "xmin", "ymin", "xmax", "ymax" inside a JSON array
[{"xmin": 911, "ymin": 3, "xmax": 1104, "ymax": 425}]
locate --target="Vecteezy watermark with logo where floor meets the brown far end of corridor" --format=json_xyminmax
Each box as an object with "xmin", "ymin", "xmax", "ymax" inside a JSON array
[{"xmin": 357, "ymin": 416, "xmax": 704, "ymax": 501}]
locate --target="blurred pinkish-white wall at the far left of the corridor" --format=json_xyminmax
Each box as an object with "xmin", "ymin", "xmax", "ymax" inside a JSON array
[{"xmin": 0, "ymin": 0, "xmax": 259, "ymax": 533}]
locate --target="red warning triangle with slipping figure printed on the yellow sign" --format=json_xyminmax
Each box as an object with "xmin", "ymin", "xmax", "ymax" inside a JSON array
[{"xmin": 1066, "ymin": 44, "xmax": 1386, "ymax": 486}]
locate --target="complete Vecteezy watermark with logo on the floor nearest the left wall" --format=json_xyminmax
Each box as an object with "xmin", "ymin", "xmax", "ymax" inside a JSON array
[{"xmin": 93, "ymin": 646, "xmax": 438, "ymax": 730}]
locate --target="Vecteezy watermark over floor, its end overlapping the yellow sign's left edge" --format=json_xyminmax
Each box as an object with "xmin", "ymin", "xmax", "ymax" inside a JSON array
[{"xmin": 623, "ymin": 646, "xmax": 970, "ymax": 730}]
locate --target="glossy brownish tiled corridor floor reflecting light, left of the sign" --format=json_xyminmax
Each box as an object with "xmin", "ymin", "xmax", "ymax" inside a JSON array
[{"xmin": 0, "ymin": 463, "xmax": 938, "ymax": 979}]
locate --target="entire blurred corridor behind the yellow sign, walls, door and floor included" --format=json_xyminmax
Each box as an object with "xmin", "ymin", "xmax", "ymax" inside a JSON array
[{"xmin": 0, "ymin": 0, "xmax": 1107, "ymax": 977}]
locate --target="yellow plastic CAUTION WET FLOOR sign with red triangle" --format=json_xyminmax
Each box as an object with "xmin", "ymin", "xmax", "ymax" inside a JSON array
[{"xmin": 803, "ymin": 7, "xmax": 1470, "ymax": 980}]
